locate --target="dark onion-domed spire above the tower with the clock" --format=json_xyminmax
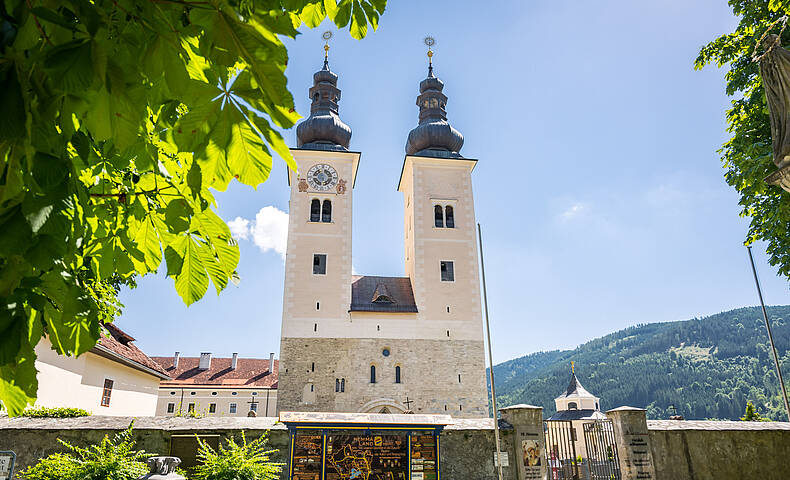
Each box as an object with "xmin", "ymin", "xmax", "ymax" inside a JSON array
[{"xmin": 296, "ymin": 59, "xmax": 351, "ymax": 151}]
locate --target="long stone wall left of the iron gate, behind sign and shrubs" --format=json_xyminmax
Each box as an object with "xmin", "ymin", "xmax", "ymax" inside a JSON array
[{"xmin": 0, "ymin": 416, "xmax": 517, "ymax": 480}]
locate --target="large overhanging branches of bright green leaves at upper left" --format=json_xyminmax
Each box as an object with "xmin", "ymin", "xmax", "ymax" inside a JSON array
[{"xmin": 0, "ymin": 0, "xmax": 386, "ymax": 415}]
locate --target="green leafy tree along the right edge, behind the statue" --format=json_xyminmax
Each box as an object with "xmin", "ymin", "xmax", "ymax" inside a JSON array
[{"xmin": 695, "ymin": 0, "xmax": 790, "ymax": 277}]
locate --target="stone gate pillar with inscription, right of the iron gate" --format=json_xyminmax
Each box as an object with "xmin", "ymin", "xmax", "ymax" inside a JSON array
[{"xmin": 606, "ymin": 407, "xmax": 656, "ymax": 480}]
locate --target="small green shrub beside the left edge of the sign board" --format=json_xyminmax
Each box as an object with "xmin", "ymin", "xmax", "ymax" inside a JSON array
[{"xmin": 193, "ymin": 431, "xmax": 283, "ymax": 480}]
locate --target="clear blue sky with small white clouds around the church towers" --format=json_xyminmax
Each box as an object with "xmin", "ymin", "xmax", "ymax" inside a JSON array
[{"xmin": 118, "ymin": 0, "xmax": 790, "ymax": 362}]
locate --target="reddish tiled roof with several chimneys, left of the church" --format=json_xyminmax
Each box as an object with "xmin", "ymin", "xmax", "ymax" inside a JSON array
[{"xmin": 153, "ymin": 357, "xmax": 280, "ymax": 388}]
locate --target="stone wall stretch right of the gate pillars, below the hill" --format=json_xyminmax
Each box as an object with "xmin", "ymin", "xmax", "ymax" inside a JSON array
[{"xmin": 647, "ymin": 420, "xmax": 790, "ymax": 480}]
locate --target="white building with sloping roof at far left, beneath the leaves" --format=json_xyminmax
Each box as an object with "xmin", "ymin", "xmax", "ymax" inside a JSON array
[{"xmin": 35, "ymin": 324, "xmax": 170, "ymax": 417}]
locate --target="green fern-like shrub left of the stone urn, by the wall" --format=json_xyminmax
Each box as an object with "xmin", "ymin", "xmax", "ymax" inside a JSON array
[{"xmin": 18, "ymin": 425, "xmax": 149, "ymax": 480}]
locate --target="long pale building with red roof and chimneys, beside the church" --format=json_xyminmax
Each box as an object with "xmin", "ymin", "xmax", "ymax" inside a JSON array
[{"xmin": 153, "ymin": 352, "xmax": 278, "ymax": 417}]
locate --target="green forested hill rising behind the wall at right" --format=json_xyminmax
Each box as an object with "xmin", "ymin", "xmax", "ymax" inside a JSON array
[{"xmin": 494, "ymin": 306, "xmax": 790, "ymax": 420}]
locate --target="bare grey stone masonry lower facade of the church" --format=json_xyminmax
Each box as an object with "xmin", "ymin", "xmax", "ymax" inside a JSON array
[{"xmin": 277, "ymin": 338, "xmax": 488, "ymax": 418}]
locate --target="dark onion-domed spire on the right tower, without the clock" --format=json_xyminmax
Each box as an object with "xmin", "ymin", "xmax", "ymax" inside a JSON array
[{"xmin": 406, "ymin": 62, "xmax": 464, "ymax": 157}]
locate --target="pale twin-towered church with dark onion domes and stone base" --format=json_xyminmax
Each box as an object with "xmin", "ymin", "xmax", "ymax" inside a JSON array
[{"xmin": 278, "ymin": 49, "xmax": 488, "ymax": 417}]
